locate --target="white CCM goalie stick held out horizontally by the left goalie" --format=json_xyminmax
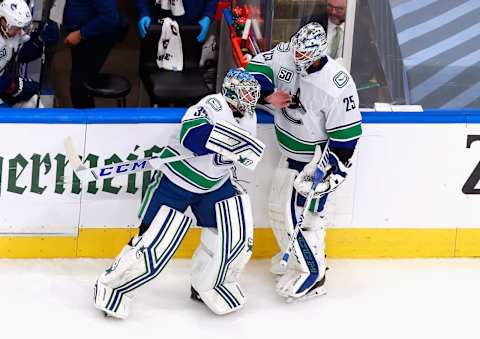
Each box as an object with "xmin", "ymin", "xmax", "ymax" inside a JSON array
[{"xmin": 63, "ymin": 137, "xmax": 198, "ymax": 182}]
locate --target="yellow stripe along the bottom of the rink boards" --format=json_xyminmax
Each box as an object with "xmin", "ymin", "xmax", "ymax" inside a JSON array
[{"xmin": 0, "ymin": 228, "xmax": 480, "ymax": 259}]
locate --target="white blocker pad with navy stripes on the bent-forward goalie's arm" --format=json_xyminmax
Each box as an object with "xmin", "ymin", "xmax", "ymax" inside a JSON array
[{"xmin": 205, "ymin": 121, "xmax": 265, "ymax": 170}]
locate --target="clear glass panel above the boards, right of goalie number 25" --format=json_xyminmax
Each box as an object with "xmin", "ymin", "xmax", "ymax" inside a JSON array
[{"xmin": 351, "ymin": 0, "xmax": 480, "ymax": 108}]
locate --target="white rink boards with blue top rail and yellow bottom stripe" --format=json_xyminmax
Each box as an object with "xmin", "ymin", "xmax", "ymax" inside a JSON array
[{"xmin": 0, "ymin": 109, "xmax": 480, "ymax": 258}]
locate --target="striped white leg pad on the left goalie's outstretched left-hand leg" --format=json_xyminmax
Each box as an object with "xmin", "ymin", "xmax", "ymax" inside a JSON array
[{"xmin": 95, "ymin": 205, "xmax": 192, "ymax": 318}]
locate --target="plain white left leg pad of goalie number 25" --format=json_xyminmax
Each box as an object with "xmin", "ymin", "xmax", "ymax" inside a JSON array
[{"xmin": 268, "ymin": 168, "xmax": 298, "ymax": 275}]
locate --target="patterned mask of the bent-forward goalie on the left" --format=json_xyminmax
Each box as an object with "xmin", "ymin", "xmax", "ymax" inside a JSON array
[{"xmin": 222, "ymin": 68, "xmax": 260, "ymax": 115}]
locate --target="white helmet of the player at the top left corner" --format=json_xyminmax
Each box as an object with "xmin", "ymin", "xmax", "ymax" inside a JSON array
[{"xmin": 0, "ymin": 0, "xmax": 32, "ymax": 39}]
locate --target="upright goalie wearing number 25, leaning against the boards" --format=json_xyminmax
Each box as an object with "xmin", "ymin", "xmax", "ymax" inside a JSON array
[{"xmin": 246, "ymin": 22, "xmax": 362, "ymax": 301}]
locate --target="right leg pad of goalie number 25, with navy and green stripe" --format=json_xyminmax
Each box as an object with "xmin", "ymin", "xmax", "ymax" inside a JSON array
[{"xmin": 277, "ymin": 212, "xmax": 326, "ymax": 301}]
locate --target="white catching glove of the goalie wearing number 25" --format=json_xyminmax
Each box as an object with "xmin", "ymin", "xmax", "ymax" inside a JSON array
[{"xmin": 293, "ymin": 152, "xmax": 351, "ymax": 199}]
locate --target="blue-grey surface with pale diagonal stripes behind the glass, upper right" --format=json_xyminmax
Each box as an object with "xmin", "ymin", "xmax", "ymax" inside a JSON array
[{"xmin": 386, "ymin": 0, "xmax": 480, "ymax": 108}]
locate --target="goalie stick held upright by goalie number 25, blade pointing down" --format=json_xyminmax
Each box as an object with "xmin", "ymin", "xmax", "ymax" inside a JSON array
[{"xmin": 280, "ymin": 142, "xmax": 330, "ymax": 267}]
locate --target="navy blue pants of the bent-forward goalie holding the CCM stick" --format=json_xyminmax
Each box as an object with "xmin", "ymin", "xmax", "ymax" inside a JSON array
[{"xmin": 139, "ymin": 171, "xmax": 237, "ymax": 234}]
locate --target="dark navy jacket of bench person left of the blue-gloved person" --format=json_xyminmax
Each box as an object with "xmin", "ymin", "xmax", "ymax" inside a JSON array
[{"xmin": 63, "ymin": 0, "xmax": 120, "ymax": 39}]
